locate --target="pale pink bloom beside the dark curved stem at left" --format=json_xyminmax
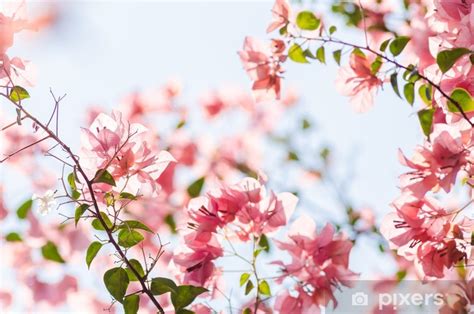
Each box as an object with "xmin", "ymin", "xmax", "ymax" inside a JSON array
[{"xmin": 81, "ymin": 111, "xmax": 175, "ymax": 194}]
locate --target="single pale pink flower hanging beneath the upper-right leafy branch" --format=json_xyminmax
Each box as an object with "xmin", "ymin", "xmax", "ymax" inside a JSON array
[{"xmin": 336, "ymin": 53, "xmax": 382, "ymax": 112}]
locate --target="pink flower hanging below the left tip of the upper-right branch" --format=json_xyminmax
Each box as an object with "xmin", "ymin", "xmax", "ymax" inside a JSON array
[{"xmin": 239, "ymin": 37, "xmax": 286, "ymax": 101}]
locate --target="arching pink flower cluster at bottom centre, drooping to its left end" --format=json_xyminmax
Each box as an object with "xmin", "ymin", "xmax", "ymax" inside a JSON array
[{"xmin": 174, "ymin": 178, "xmax": 297, "ymax": 285}]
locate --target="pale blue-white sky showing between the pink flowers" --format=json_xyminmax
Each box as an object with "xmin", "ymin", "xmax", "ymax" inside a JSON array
[{"xmin": 0, "ymin": 1, "xmax": 430, "ymax": 310}]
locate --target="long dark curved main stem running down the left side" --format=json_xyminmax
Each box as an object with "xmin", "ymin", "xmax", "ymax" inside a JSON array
[{"xmin": 0, "ymin": 93, "xmax": 164, "ymax": 314}]
